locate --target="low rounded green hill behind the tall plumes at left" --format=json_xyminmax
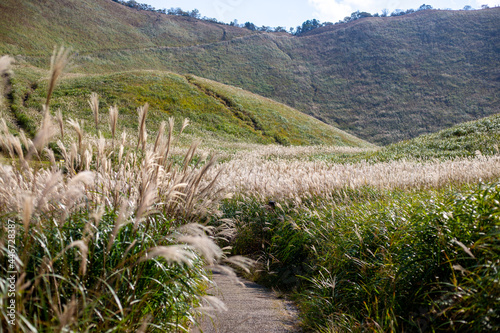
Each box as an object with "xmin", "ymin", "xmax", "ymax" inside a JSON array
[{"xmin": 4, "ymin": 67, "xmax": 370, "ymax": 147}]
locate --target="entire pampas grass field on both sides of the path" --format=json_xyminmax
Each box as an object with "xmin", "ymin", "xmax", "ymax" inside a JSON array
[{"xmin": 0, "ymin": 48, "xmax": 500, "ymax": 332}]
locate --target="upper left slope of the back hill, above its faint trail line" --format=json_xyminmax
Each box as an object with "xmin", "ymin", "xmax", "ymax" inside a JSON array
[{"xmin": 0, "ymin": 0, "xmax": 251, "ymax": 55}]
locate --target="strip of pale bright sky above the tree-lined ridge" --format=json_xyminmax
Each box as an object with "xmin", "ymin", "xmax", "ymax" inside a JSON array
[{"xmin": 140, "ymin": 0, "xmax": 500, "ymax": 28}]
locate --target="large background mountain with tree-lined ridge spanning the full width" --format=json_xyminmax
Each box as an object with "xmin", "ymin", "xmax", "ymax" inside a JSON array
[{"xmin": 0, "ymin": 0, "xmax": 500, "ymax": 144}]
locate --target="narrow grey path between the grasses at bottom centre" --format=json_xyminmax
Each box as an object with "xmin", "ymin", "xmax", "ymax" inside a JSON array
[{"xmin": 191, "ymin": 271, "xmax": 300, "ymax": 333}]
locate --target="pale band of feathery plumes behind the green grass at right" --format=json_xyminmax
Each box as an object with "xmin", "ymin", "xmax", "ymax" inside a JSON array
[{"xmin": 206, "ymin": 147, "xmax": 500, "ymax": 199}]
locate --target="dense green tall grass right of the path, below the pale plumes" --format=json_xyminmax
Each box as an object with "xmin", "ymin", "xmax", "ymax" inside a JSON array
[{"xmin": 224, "ymin": 183, "xmax": 500, "ymax": 332}]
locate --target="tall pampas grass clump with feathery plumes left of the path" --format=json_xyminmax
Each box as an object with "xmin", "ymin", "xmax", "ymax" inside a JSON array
[{"xmin": 0, "ymin": 49, "xmax": 248, "ymax": 332}]
